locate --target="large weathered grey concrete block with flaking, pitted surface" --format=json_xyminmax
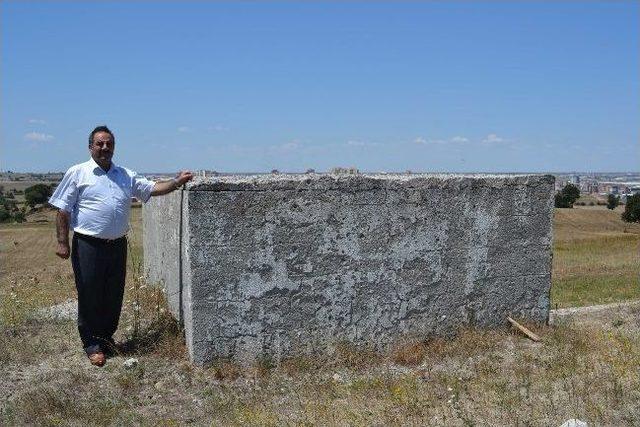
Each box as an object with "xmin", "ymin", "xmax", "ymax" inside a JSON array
[{"xmin": 144, "ymin": 174, "xmax": 553, "ymax": 363}]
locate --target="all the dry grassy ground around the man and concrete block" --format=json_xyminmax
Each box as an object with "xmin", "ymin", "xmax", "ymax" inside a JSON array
[{"xmin": 0, "ymin": 204, "xmax": 640, "ymax": 426}]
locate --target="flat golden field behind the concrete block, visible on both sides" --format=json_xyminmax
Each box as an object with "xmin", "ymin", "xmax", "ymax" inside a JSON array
[{"xmin": 0, "ymin": 206, "xmax": 640, "ymax": 314}]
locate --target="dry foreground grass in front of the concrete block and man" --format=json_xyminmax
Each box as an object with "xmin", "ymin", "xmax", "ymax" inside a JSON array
[{"xmin": 0, "ymin": 307, "xmax": 640, "ymax": 425}]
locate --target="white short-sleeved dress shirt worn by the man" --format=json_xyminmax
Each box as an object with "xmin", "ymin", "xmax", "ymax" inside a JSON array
[{"xmin": 49, "ymin": 159, "xmax": 155, "ymax": 239}]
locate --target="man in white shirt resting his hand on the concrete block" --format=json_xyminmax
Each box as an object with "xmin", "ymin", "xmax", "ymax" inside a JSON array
[{"xmin": 49, "ymin": 126, "xmax": 193, "ymax": 366}]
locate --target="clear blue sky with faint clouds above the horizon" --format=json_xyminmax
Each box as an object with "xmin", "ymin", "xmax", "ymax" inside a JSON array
[{"xmin": 0, "ymin": 1, "xmax": 640, "ymax": 172}]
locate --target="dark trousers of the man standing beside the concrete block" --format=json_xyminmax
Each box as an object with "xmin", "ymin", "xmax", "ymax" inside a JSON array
[{"xmin": 71, "ymin": 233, "xmax": 127, "ymax": 354}]
